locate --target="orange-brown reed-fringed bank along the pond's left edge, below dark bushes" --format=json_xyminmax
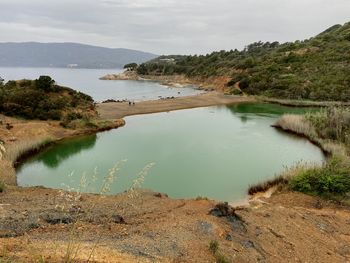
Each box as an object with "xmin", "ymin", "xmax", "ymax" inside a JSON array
[{"xmin": 0, "ymin": 117, "xmax": 125, "ymax": 185}]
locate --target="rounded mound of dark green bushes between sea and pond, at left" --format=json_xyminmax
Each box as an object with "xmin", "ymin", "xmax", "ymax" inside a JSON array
[{"xmin": 0, "ymin": 76, "xmax": 94, "ymax": 120}]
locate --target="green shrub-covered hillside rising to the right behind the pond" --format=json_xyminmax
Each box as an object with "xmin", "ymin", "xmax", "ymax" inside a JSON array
[{"xmin": 138, "ymin": 23, "xmax": 350, "ymax": 101}]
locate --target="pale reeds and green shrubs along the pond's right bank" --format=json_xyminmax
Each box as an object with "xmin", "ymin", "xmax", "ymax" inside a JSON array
[{"xmin": 270, "ymin": 107, "xmax": 350, "ymax": 203}]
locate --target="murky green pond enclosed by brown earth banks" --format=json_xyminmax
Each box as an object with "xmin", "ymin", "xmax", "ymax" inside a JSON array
[{"xmin": 17, "ymin": 104, "xmax": 324, "ymax": 201}]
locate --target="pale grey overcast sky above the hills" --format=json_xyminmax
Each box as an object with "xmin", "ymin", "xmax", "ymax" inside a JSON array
[{"xmin": 0, "ymin": 0, "xmax": 350, "ymax": 54}]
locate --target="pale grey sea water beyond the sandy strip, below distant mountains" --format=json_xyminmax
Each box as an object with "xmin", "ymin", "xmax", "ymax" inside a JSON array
[{"xmin": 0, "ymin": 68, "xmax": 202, "ymax": 101}]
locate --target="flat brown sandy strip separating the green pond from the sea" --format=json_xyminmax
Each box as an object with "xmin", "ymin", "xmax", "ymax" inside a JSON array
[{"xmin": 97, "ymin": 92, "xmax": 255, "ymax": 119}]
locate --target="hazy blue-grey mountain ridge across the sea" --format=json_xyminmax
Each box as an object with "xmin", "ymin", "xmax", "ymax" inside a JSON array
[{"xmin": 0, "ymin": 42, "xmax": 157, "ymax": 68}]
